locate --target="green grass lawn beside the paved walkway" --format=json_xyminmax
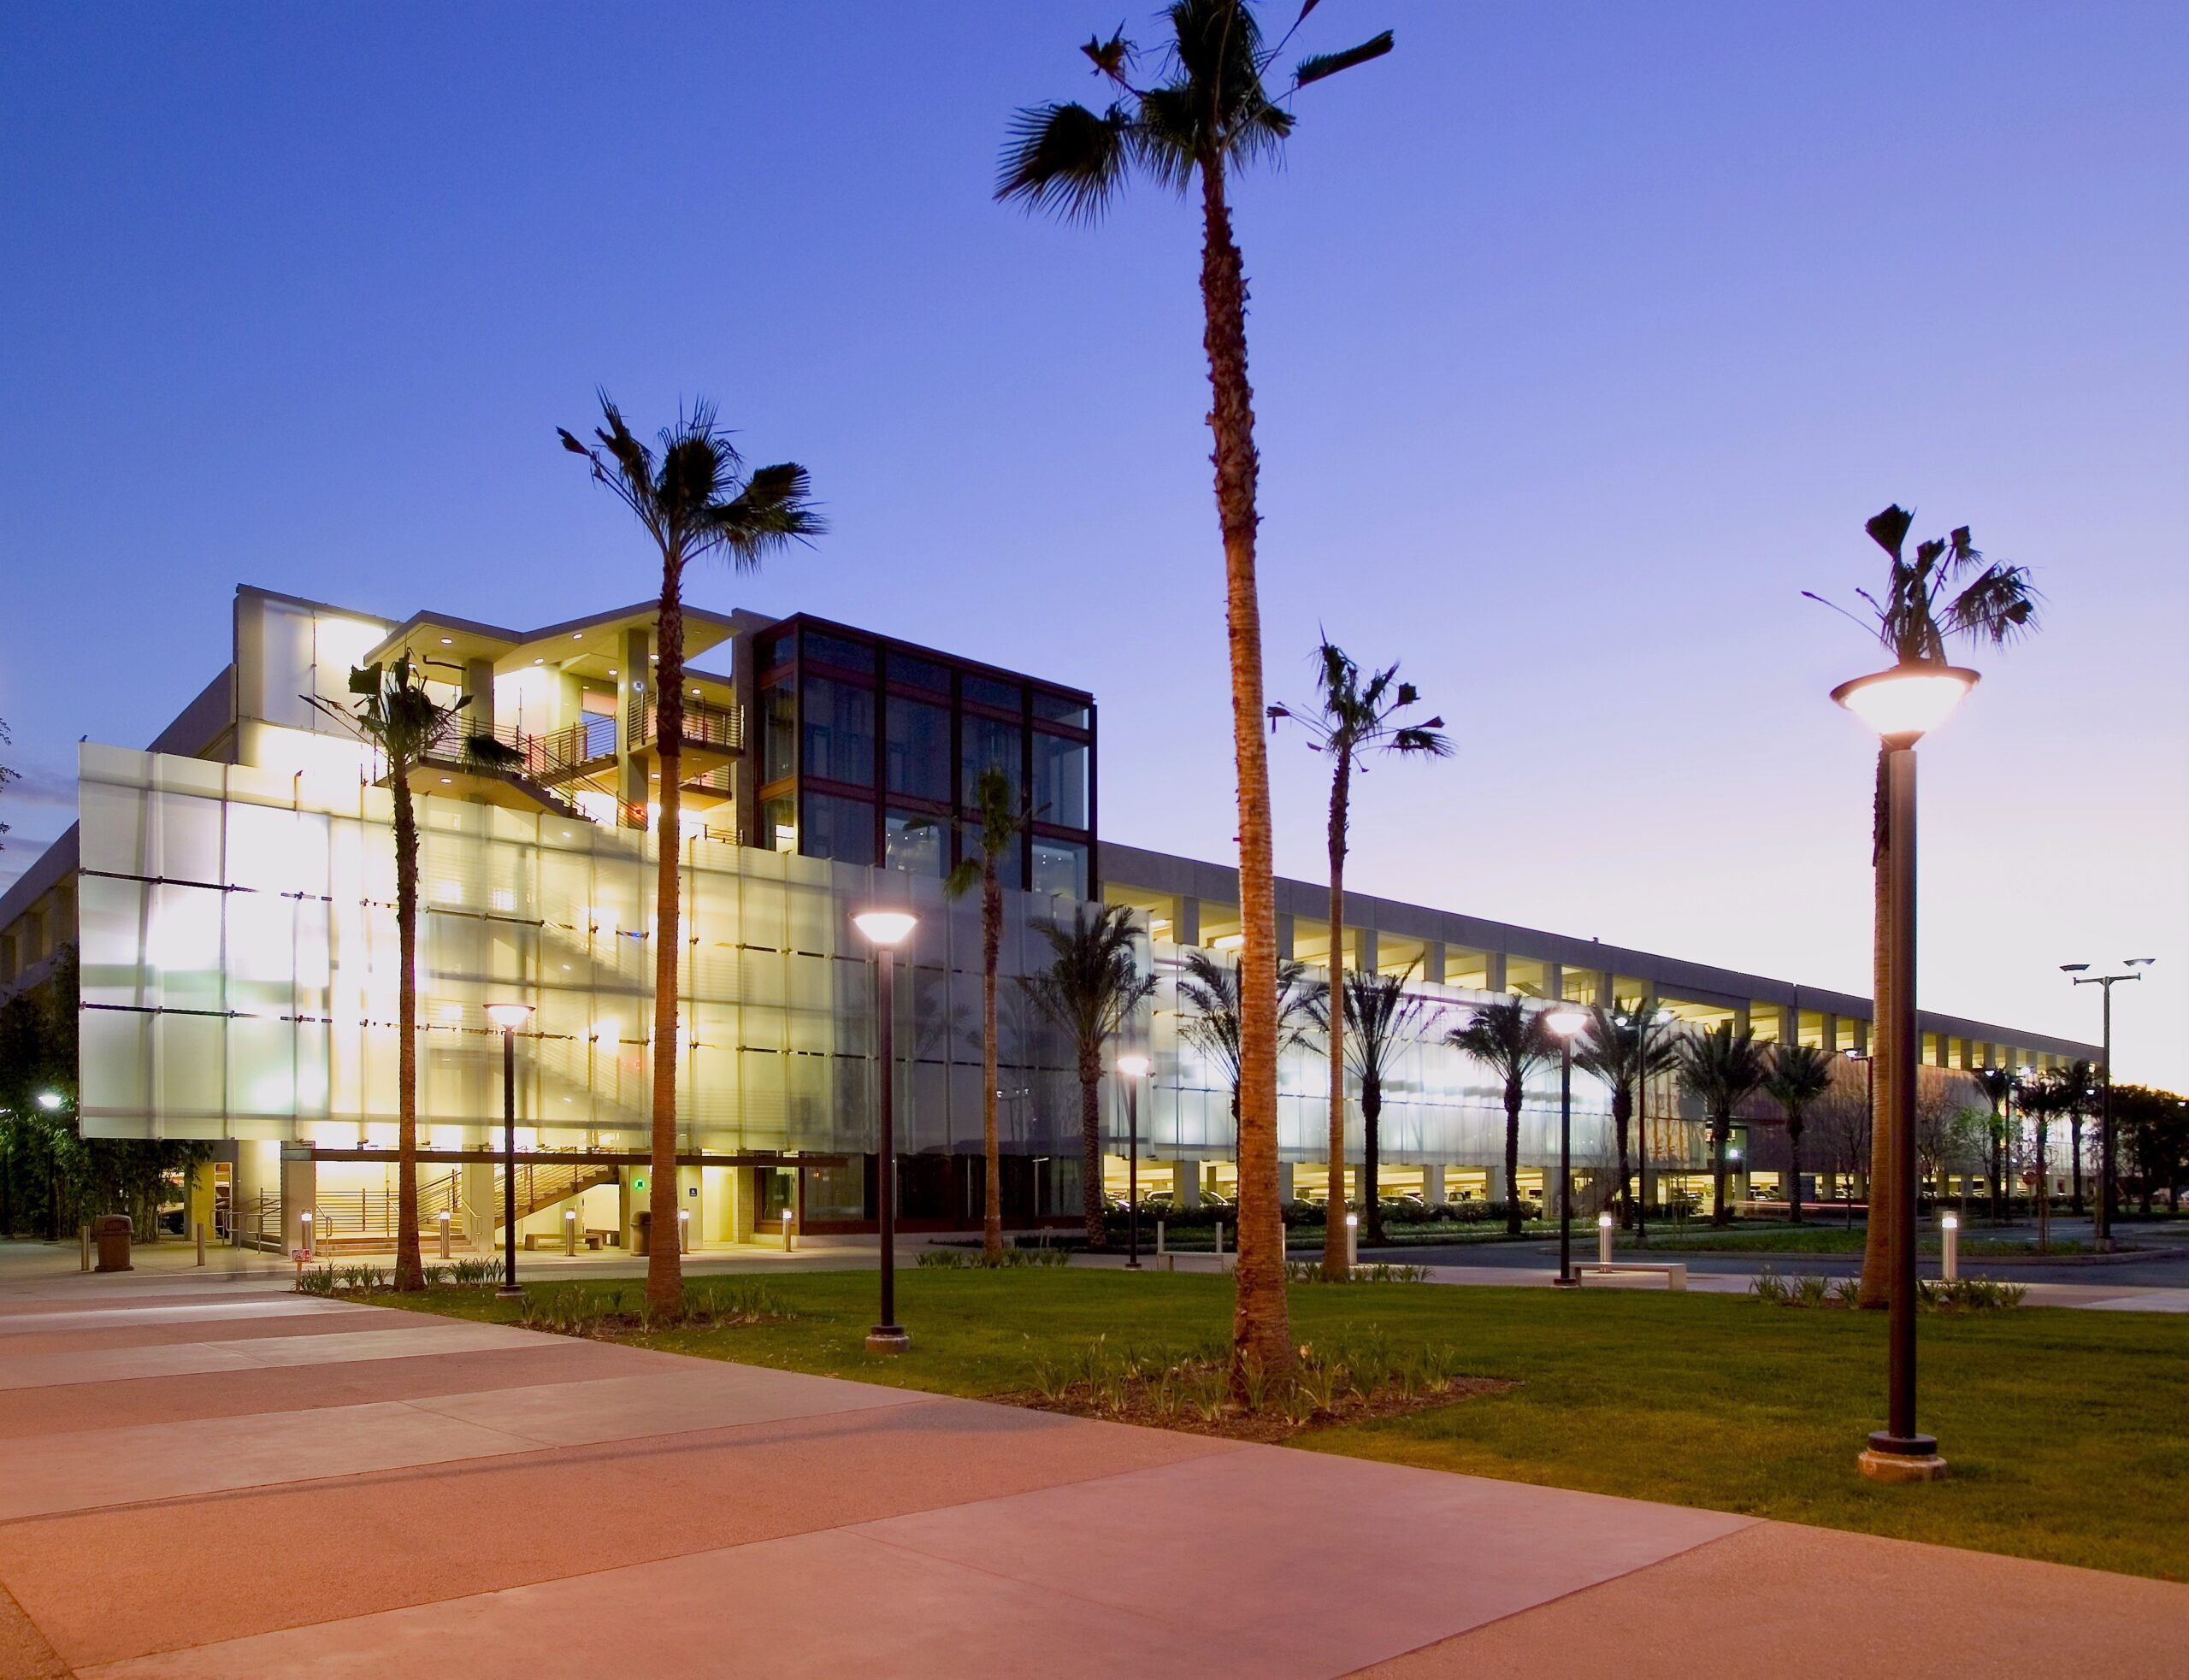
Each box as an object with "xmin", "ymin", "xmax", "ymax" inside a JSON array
[{"xmin": 389, "ymin": 1269, "xmax": 2189, "ymax": 1579}]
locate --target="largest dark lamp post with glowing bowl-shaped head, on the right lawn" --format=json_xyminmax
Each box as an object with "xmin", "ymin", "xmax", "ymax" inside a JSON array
[{"xmin": 1832, "ymin": 661, "xmax": 1977, "ymax": 1481}]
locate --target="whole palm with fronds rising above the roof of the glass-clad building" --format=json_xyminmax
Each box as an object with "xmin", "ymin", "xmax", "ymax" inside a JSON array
[{"xmin": 556, "ymin": 392, "xmax": 823, "ymax": 1312}]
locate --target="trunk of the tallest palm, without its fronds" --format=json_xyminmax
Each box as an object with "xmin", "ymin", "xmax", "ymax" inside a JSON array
[{"xmin": 1200, "ymin": 156, "xmax": 1291, "ymax": 1394}]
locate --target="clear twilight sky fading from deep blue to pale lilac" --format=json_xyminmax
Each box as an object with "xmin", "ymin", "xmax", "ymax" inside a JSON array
[{"xmin": 0, "ymin": 0, "xmax": 2189, "ymax": 1089}]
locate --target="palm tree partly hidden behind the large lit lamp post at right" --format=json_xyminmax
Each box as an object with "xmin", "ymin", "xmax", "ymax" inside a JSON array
[{"xmin": 1802, "ymin": 503, "xmax": 2038, "ymax": 1308}]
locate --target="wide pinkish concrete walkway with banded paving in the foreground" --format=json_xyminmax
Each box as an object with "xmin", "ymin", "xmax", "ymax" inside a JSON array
[{"xmin": 0, "ymin": 1252, "xmax": 2189, "ymax": 1680}]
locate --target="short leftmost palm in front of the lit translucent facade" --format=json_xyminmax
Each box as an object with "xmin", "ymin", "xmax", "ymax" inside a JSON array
[{"xmin": 304, "ymin": 650, "xmax": 494, "ymax": 1288}]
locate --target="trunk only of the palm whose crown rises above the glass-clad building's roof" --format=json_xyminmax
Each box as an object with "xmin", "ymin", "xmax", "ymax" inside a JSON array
[{"xmin": 641, "ymin": 560, "xmax": 683, "ymax": 1312}]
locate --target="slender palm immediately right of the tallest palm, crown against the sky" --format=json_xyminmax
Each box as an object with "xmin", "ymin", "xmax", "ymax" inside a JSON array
[{"xmin": 1270, "ymin": 637, "xmax": 1451, "ymax": 1277}]
